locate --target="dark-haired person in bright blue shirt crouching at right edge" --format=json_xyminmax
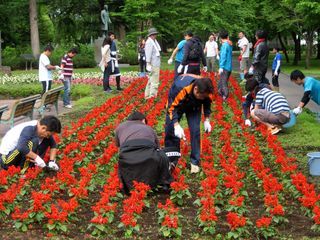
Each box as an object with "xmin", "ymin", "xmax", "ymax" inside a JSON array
[{"xmin": 290, "ymin": 70, "xmax": 320, "ymax": 115}]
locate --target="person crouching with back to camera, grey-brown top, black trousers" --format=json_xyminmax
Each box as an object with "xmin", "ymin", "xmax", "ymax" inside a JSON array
[{"xmin": 115, "ymin": 112, "xmax": 180, "ymax": 195}]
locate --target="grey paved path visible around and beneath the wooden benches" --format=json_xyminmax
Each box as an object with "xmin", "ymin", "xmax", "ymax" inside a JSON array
[{"xmin": 0, "ymin": 100, "xmax": 72, "ymax": 139}]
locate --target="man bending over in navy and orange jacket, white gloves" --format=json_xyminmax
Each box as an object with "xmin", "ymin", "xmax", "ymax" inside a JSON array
[{"xmin": 165, "ymin": 74, "xmax": 213, "ymax": 173}]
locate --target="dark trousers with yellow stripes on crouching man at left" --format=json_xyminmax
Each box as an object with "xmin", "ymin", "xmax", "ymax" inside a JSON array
[{"xmin": 0, "ymin": 138, "xmax": 49, "ymax": 170}]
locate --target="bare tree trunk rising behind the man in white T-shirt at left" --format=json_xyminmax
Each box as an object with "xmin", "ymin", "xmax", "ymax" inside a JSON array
[{"xmin": 29, "ymin": 0, "xmax": 40, "ymax": 58}]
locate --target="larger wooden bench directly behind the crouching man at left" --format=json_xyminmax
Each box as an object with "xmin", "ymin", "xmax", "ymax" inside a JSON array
[{"xmin": 0, "ymin": 94, "xmax": 41, "ymax": 128}]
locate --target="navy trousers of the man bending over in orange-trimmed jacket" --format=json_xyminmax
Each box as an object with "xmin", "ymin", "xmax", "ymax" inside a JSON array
[{"xmin": 164, "ymin": 107, "xmax": 201, "ymax": 165}]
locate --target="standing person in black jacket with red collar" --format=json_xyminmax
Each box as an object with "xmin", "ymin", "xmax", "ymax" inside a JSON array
[{"xmin": 249, "ymin": 30, "xmax": 269, "ymax": 84}]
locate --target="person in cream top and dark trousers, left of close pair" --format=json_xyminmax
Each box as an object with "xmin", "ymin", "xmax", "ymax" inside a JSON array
[{"xmin": 99, "ymin": 37, "xmax": 112, "ymax": 93}]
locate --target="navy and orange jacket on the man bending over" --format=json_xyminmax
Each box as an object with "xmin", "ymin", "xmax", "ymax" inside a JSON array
[{"xmin": 167, "ymin": 75, "xmax": 212, "ymax": 123}]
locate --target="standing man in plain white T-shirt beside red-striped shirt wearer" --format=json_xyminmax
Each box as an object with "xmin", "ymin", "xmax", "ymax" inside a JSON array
[{"xmin": 39, "ymin": 45, "xmax": 60, "ymax": 95}]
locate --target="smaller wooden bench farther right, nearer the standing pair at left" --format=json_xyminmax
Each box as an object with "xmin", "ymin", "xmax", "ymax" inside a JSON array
[{"xmin": 34, "ymin": 86, "xmax": 64, "ymax": 117}]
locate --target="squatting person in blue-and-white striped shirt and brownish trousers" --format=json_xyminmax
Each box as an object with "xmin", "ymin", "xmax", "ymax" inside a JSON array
[{"xmin": 251, "ymin": 86, "xmax": 290, "ymax": 135}]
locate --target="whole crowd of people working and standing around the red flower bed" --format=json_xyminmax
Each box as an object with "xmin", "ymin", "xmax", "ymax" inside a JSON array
[{"xmin": 0, "ymin": 28, "xmax": 320, "ymax": 197}]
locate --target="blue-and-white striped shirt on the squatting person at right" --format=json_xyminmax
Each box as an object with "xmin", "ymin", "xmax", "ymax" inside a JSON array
[{"xmin": 255, "ymin": 88, "xmax": 290, "ymax": 114}]
